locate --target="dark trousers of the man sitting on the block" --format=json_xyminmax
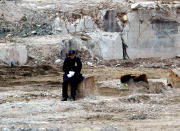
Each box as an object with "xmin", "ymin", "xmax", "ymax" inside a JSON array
[{"xmin": 62, "ymin": 74, "xmax": 83, "ymax": 98}]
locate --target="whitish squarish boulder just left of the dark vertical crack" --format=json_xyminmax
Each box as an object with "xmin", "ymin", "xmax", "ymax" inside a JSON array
[{"xmin": 88, "ymin": 31, "xmax": 123, "ymax": 60}]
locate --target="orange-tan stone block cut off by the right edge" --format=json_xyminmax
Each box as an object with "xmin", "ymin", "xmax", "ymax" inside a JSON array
[{"xmin": 168, "ymin": 68, "xmax": 180, "ymax": 88}]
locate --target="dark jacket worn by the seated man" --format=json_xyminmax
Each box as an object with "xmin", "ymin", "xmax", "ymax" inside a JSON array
[{"xmin": 63, "ymin": 56, "xmax": 82, "ymax": 75}]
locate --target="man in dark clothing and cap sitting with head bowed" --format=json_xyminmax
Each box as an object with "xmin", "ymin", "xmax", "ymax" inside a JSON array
[{"xmin": 61, "ymin": 50, "xmax": 83, "ymax": 101}]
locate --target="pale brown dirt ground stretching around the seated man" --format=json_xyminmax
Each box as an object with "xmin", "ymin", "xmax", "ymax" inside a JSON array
[{"xmin": 0, "ymin": 60, "xmax": 180, "ymax": 131}]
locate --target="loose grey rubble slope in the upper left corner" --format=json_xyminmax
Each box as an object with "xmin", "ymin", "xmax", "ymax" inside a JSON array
[{"xmin": 0, "ymin": 3, "xmax": 53, "ymax": 37}]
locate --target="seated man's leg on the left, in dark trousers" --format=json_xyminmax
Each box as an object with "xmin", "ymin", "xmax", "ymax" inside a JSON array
[{"xmin": 62, "ymin": 74, "xmax": 68, "ymax": 101}]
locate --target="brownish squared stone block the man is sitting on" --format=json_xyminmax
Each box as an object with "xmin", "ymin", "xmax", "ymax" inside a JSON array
[{"xmin": 68, "ymin": 75, "xmax": 95, "ymax": 98}]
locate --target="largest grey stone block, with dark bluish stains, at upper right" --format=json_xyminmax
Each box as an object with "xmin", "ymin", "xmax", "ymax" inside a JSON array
[{"xmin": 123, "ymin": 10, "xmax": 180, "ymax": 59}]
